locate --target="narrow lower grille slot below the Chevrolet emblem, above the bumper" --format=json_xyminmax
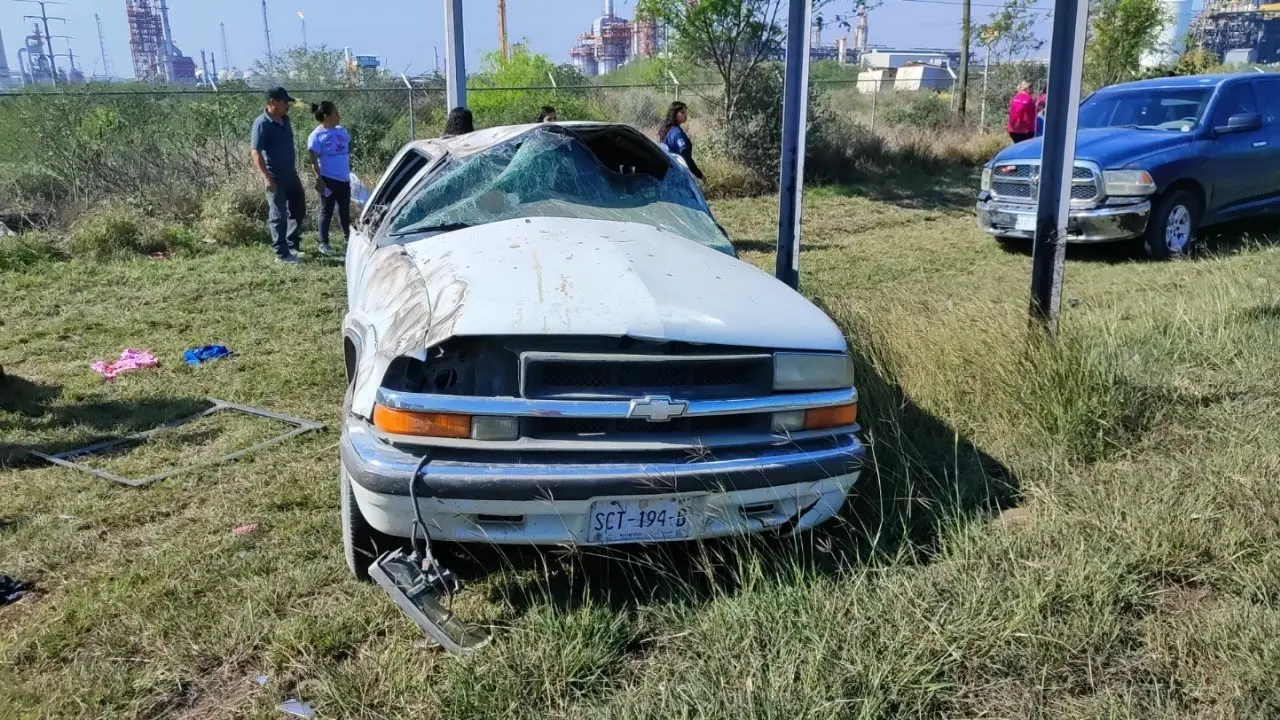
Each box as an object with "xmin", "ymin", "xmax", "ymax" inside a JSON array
[{"xmin": 521, "ymin": 414, "xmax": 771, "ymax": 439}]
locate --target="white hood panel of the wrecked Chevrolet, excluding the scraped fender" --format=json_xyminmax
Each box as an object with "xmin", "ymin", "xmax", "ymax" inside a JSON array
[{"xmin": 394, "ymin": 218, "xmax": 845, "ymax": 351}]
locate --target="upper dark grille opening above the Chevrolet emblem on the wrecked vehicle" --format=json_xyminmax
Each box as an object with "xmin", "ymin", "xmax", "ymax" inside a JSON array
[{"xmin": 520, "ymin": 352, "xmax": 773, "ymax": 400}]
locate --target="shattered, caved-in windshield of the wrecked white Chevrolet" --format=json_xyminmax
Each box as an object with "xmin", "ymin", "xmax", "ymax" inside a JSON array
[{"xmin": 390, "ymin": 131, "xmax": 733, "ymax": 255}]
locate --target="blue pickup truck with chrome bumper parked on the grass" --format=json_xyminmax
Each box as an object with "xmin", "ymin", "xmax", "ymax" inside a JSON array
[{"xmin": 978, "ymin": 73, "xmax": 1280, "ymax": 259}]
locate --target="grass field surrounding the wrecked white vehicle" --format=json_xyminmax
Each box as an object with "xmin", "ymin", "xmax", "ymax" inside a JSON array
[{"xmin": 0, "ymin": 178, "xmax": 1280, "ymax": 720}]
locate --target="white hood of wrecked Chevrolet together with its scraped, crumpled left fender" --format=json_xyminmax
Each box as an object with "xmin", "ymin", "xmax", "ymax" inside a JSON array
[{"xmin": 344, "ymin": 218, "xmax": 846, "ymax": 418}]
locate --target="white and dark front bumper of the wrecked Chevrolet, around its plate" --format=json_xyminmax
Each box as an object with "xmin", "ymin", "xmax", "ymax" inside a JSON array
[{"xmin": 340, "ymin": 419, "xmax": 867, "ymax": 544}]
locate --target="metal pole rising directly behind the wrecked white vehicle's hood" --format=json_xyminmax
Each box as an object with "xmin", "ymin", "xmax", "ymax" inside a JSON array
[{"xmin": 774, "ymin": 0, "xmax": 813, "ymax": 288}]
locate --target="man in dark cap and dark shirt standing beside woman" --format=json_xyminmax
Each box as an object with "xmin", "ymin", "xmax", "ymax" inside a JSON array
[{"xmin": 252, "ymin": 87, "xmax": 307, "ymax": 264}]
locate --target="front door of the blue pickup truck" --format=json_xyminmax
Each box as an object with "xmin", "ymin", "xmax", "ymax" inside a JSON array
[{"xmin": 1204, "ymin": 81, "xmax": 1272, "ymax": 215}]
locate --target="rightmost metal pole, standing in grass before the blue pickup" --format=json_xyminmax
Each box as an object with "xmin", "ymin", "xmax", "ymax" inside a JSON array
[{"xmin": 1030, "ymin": 0, "xmax": 1089, "ymax": 338}]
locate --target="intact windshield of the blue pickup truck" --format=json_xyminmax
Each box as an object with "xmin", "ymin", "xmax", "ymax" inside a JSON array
[{"xmin": 1080, "ymin": 87, "xmax": 1213, "ymax": 132}]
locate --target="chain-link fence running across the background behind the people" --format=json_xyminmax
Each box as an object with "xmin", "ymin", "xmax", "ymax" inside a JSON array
[{"xmin": 0, "ymin": 72, "xmax": 1037, "ymax": 220}]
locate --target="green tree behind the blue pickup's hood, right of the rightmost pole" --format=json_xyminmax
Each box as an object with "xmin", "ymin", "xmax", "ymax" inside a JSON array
[{"xmin": 1084, "ymin": 0, "xmax": 1170, "ymax": 88}]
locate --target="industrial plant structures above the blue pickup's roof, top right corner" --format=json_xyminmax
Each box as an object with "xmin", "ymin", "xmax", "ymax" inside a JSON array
[{"xmin": 1187, "ymin": 0, "xmax": 1280, "ymax": 64}]
